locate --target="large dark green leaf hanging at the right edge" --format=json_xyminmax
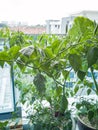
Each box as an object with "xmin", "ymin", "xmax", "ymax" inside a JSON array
[{"xmin": 87, "ymin": 47, "xmax": 98, "ymax": 67}]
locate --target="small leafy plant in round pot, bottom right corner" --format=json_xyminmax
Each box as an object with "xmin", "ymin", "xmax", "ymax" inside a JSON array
[{"xmin": 76, "ymin": 98, "xmax": 98, "ymax": 130}]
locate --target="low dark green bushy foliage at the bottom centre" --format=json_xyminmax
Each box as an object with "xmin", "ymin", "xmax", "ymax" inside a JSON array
[{"xmin": 28, "ymin": 102, "xmax": 72, "ymax": 130}]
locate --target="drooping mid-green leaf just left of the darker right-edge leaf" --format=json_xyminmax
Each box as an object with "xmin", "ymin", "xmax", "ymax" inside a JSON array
[{"xmin": 69, "ymin": 54, "xmax": 81, "ymax": 72}]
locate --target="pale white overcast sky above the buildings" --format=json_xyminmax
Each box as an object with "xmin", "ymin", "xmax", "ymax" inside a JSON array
[{"xmin": 0, "ymin": 0, "xmax": 98, "ymax": 25}]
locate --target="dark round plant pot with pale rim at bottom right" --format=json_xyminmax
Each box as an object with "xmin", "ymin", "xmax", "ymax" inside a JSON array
[{"xmin": 77, "ymin": 116, "xmax": 96, "ymax": 130}]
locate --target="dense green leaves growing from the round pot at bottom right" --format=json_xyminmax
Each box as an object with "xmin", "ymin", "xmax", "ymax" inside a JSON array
[{"xmin": 76, "ymin": 98, "xmax": 98, "ymax": 129}]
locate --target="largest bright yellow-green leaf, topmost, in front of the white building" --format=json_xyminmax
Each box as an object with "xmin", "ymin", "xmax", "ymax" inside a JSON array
[{"xmin": 68, "ymin": 16, "xmax": 95, "ymax": 42}]
